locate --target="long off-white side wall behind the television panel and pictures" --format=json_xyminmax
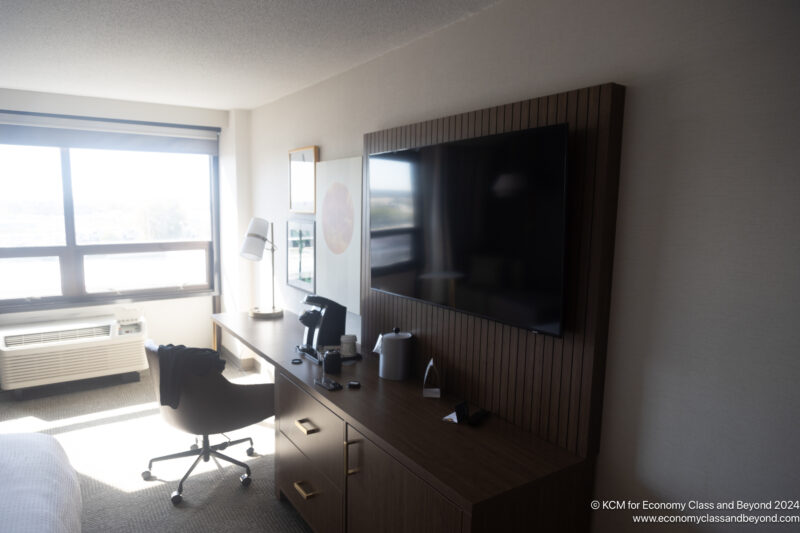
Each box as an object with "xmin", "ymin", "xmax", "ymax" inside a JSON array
[{"xmin": 252, "ymin": 0, "xmax": 800, "ymax": 531}]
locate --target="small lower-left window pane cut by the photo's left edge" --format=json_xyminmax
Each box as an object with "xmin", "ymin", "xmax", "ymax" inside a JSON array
[{"xmin": 0, "ymin": 257, "xmax": 61, "ymax": 300}]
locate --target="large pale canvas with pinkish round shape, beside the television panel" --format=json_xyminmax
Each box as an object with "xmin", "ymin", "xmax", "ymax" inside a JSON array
[{"xmin": 316, "ymin": 157, "xmax": 362, "ymax": 315}]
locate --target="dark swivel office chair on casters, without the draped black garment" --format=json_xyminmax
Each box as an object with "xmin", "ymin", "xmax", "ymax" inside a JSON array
[{"xmin": 142, "ymin": 343, "xmax": 275, "ymax": 505}]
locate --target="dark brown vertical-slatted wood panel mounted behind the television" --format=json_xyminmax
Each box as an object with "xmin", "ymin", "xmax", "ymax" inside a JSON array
[{"xmin": 361, "ymin": 85, "xmax": 624, "ymax": 462}]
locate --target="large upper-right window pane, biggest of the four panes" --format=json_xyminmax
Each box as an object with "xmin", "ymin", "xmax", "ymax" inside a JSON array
[{"xmin": 70, "ymin": 149, "xmax": 211, "ymax": 243}]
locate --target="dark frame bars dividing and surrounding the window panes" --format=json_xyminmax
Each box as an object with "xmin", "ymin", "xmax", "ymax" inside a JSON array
[{"xmin": 0, "ymin": 143, "xmax": 220, "ymax": 314}]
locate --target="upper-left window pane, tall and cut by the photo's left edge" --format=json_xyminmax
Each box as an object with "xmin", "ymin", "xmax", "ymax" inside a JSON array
[{"xmin": 0, "ymin": 144, "xmax": 66, "ymax": 248}]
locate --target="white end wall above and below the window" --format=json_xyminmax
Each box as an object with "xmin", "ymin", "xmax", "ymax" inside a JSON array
[{"xmin": 0, "ymin": 89, "xmax": 228, "ymax": 347}]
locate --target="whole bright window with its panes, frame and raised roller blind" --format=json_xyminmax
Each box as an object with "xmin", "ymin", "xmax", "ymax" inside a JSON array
[{"xmin": 0, "ymin": 112, "xmax": 218, "ymax": 312}]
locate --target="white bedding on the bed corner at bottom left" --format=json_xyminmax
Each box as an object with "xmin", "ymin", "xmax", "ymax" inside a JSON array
[{"xmin": 0, "ymin": 433, "xmax": 82, "ymax": 533}]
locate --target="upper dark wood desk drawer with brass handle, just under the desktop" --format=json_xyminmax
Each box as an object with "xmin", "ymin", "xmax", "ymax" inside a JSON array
[{"xmin": 275, "ymin": 374, "xmax": 344, "ymax": 490}]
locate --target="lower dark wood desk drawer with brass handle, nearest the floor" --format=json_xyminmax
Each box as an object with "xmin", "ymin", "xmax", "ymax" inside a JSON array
[{"xmin": 275, "ymin": 431, "xmax": 344, "ymax": 533}]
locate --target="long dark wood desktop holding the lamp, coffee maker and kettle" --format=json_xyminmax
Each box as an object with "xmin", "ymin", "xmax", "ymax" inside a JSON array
[{"xmin": 212, "ymin": 313, "xmax": 583, "ymax": 512}]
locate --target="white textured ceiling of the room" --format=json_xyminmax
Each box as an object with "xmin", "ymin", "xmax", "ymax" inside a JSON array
[{"xmin": 0, "ymin": 0, "xmax": 497, "ymax": 109}]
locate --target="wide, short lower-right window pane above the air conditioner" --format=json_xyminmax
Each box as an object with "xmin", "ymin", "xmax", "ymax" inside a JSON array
[{"xmin": 83, "ymin": 250, "xmax": 208, "ymax": 293}]
